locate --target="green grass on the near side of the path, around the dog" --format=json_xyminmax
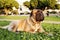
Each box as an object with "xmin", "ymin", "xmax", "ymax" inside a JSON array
[{"xmin": 0, "ymin": 21, "xmax": 60, "ymax": 40}]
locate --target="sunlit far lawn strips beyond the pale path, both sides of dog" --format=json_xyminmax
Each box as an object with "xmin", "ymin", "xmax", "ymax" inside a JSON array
[{"xmin": 0, "ymin": 16, "xmax": 60, "ymax": 21}]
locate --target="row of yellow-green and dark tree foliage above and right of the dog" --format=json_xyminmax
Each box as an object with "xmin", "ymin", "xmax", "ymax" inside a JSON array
[{"xmin": 24, "ymin": 0, "xmax": 56, "ymax": 9}]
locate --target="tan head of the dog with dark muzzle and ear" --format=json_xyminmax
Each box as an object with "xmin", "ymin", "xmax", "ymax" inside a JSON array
[{"xmin": 30, "ymin": 9, "xmax": 44, "ymax": 22}]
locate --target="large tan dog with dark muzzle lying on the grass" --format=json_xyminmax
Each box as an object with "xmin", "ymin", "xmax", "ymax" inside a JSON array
[{"xmin": 1, "ymin": 9, "xmax": 45, "ymax": 33}]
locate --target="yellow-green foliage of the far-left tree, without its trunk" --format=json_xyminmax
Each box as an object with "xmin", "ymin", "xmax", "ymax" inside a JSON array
[{"xmin": 0, "ymin": 0, "xmax": 19, "ymax": 9}]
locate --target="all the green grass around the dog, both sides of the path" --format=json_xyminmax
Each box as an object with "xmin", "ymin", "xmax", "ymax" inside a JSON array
[{"xmin": 0, "ymin": 16, "xmax": 60, "ymax": 40}]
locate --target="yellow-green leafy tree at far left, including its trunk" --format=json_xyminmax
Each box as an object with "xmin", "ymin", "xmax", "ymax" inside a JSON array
[{"xmin": 0, "ymin": 0, "xmax": 19, "ymax": 15}]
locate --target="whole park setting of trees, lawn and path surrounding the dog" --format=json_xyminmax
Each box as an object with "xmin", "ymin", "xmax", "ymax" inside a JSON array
[{"xmin": 0, "ymin": 0, "xmax": 60, "ymax": 40}]
